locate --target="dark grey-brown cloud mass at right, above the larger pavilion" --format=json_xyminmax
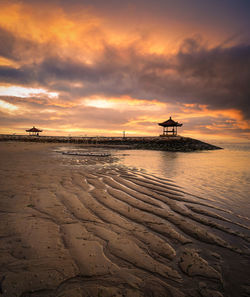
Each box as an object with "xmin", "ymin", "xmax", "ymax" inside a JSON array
[{"xmin": 174, "ymin": 40, "xmax": 250, "ymax": 119}]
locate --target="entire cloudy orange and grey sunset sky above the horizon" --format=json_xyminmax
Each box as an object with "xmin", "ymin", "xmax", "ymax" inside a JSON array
[{"xmin": 0, "ymin": 0, "xmax": 250, "ymax": 141}]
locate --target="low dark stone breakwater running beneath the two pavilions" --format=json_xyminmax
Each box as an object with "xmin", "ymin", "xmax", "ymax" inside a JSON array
[{"xmin": 0, "ymin": 134, "xmax": 222, "ymax": 152}]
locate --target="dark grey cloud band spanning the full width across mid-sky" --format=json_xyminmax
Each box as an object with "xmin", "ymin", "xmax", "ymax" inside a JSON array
[{"xmin": 0, "ymin": 24, "xmax": 250, "ymax": 119}]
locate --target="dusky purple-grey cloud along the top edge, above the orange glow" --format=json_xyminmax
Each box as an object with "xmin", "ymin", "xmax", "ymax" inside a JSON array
[{"xmin": 29, "ymin": 0, "xmax": 250, "ymax": 38}]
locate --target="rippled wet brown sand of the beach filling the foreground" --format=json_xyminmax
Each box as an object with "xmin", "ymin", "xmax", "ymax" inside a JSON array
[{"xmin": 0, "ymin": 142, "xmax": 250, "ymax": 297}]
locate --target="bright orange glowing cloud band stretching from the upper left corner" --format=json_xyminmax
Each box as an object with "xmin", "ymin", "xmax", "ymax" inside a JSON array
[{"xmin": 0, "ymin": 1, "xmax": 184, "ymax": 63}]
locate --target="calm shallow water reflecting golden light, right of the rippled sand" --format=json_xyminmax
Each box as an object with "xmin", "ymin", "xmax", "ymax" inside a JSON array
[{"xmin": 116, "ymin": 143, "xmax": 250, "ymax": 217}]
